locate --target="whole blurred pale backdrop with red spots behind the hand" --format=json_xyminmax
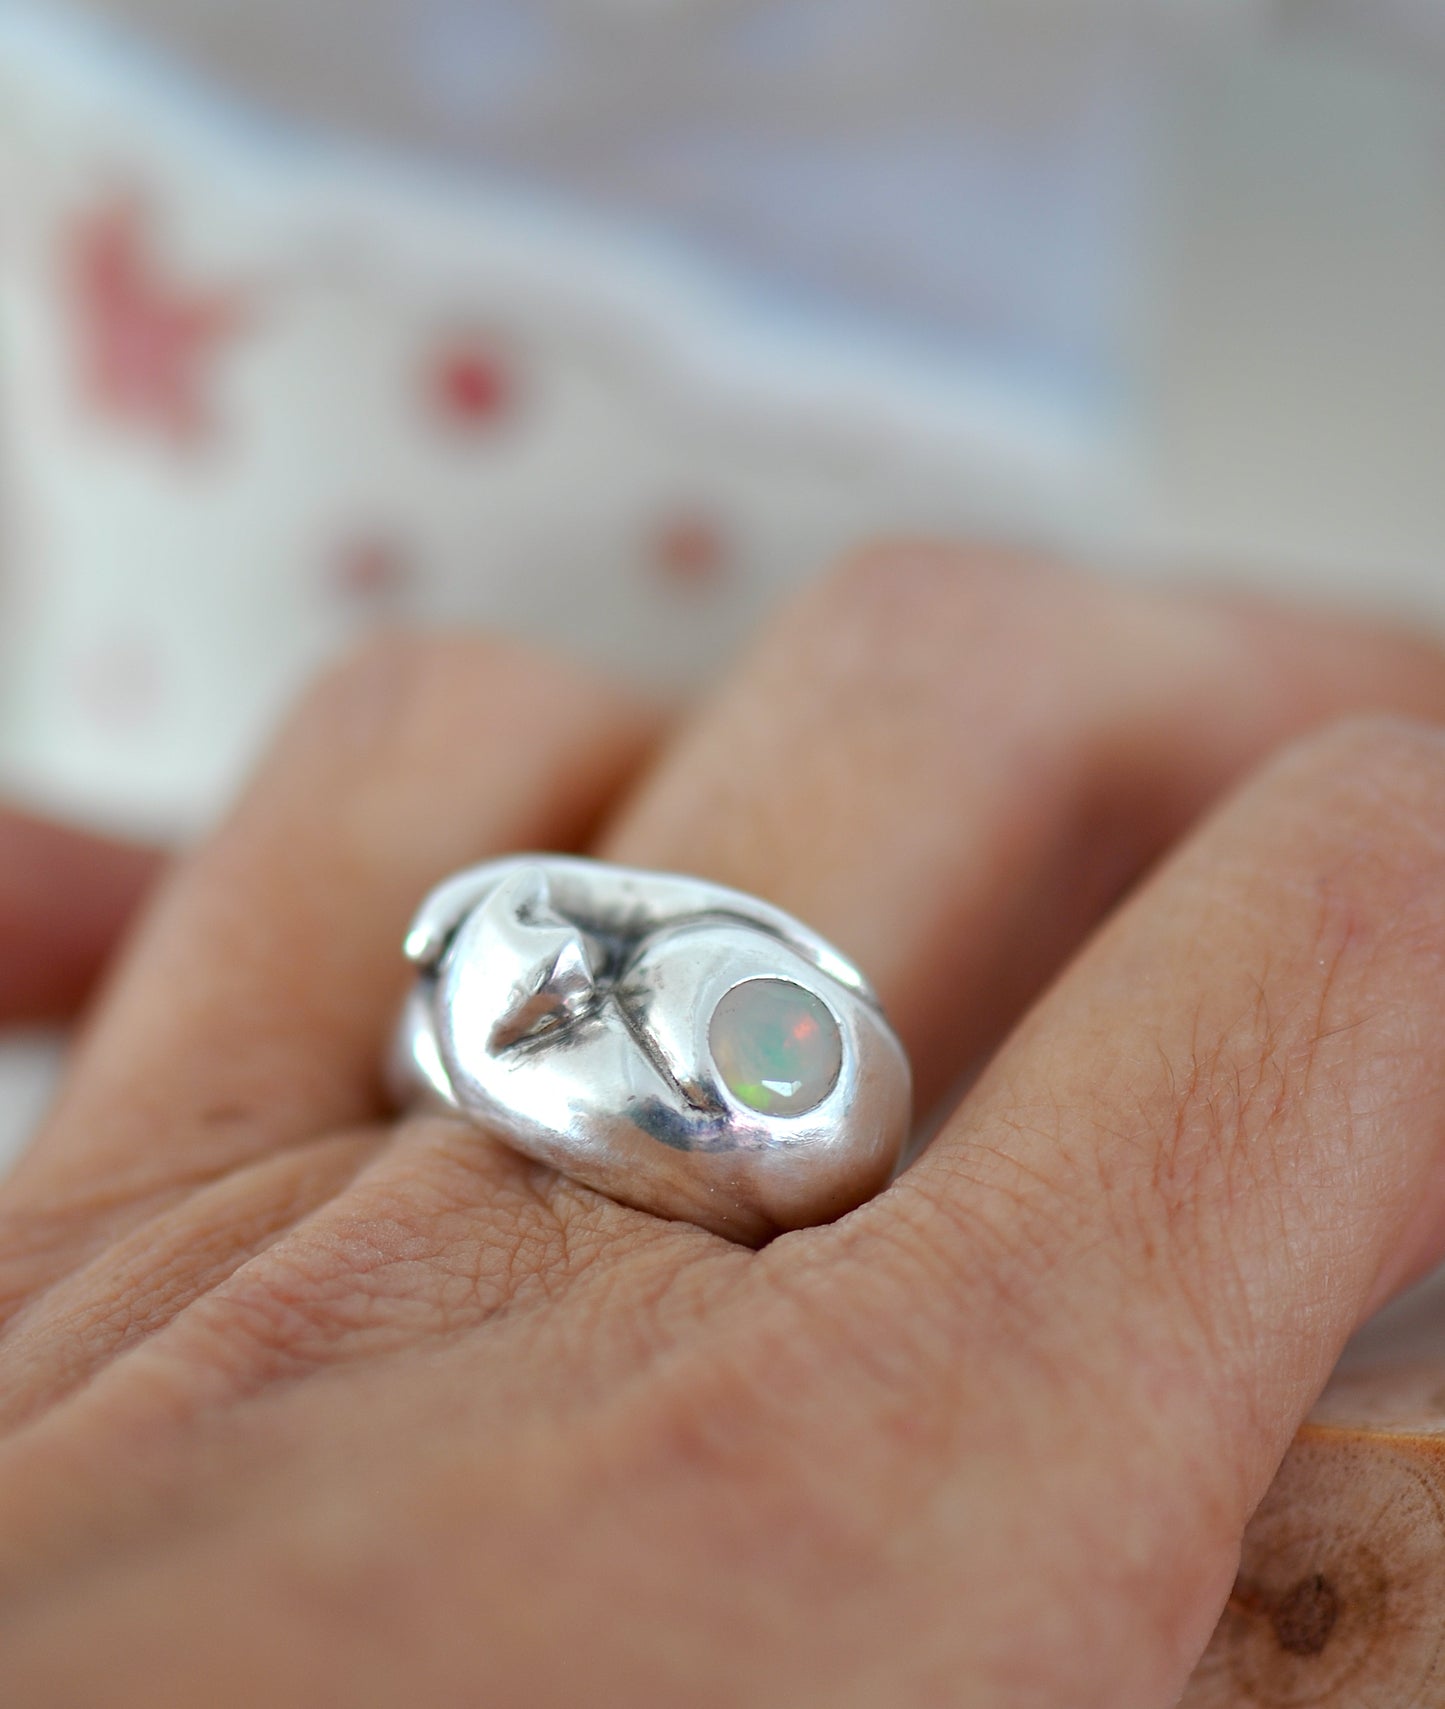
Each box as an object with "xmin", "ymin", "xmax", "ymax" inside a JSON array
[{"xmin": 0, "ymin": 0, "xmax": 1445, "ymax": 1162}]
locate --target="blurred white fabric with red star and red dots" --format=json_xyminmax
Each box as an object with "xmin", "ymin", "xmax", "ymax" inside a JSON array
[{"xmin": 0, "ymin": 3, "xmax": 1127, "ymax": 840}]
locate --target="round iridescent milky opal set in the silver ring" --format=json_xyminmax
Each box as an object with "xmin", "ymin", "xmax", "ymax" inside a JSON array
[{"xmin": 707, "ymin": 979, "xmax": 842, "ymax": 1116}]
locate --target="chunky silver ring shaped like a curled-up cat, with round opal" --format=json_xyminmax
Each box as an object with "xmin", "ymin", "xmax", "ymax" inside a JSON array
[{"xmin": 391, "ymin": 855, "xmax": 910, "ymax": 1246}]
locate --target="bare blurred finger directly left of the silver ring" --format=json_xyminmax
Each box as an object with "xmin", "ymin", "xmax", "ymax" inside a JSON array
[{"xmin": 10, "ymin": 637, "xmax": 651, "ymax": 1250}]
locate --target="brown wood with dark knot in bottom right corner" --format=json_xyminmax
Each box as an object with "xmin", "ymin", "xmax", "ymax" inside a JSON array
[{"xmin": 1182, "ymin": 1278, "xmax": 1445, "ymax": 1709}]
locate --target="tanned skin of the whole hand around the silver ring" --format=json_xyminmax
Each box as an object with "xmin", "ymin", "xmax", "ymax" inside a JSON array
[{"xmin": 0, "ymin": 549, "xmax": 1445, "ymax": 1709}]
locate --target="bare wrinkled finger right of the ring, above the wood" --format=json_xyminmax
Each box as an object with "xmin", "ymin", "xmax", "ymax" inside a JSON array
[{"xmin": 808, "ymin": 725, "xmax": 1445, "ymax": 1702}]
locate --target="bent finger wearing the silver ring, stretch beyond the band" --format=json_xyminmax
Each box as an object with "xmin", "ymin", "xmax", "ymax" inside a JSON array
[{"xmin": 601, "ymin": 550, "xmax": 1445, "ymax": 1107}]
